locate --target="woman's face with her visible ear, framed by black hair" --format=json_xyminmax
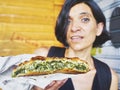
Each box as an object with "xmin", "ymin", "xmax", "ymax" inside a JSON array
[{"xmin": 67, "ymin": 3, "xmax": 103, "ymax": 50}]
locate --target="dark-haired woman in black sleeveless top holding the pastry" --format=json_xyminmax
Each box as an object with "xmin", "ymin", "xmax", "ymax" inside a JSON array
[{"xmin": 33, "ymin": 0, "xmax": 118, "ymax": 90}]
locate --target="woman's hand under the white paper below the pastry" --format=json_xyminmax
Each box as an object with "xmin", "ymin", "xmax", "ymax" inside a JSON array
[{"xmin": 44, "ymin": 79, "xmax": 67, "ymax": 90}]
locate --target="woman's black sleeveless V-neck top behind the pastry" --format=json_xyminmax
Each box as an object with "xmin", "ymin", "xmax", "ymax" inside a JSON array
[{"xmin": 47, "ymin": 47, "xmax": 111, "ymax": 90}]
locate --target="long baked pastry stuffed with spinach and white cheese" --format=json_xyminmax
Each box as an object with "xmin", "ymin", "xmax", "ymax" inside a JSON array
[{"xmin": 12, "ymin": 56, "xmax": 90, "ymax": 77}]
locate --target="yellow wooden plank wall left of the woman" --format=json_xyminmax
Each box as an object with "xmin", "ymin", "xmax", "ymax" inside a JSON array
[{"xmin": 0, "ymin": 0, "xmax": 64, "ymax": 56}]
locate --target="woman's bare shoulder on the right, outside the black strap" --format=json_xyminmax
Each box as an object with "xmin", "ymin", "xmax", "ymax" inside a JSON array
[{"xmin": 110, "ymin": 69, "xmax": 118, "ymax": 90}]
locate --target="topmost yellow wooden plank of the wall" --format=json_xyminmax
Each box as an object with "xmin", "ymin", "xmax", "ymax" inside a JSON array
[{"xmin": 0, "ymin": 0, "xmax": 53, "ymax": 9}]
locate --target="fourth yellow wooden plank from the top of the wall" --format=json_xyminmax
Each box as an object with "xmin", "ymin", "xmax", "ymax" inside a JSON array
[{"xmin": 0, "ymin": 23, "xmax": 54, "ymax": 33}]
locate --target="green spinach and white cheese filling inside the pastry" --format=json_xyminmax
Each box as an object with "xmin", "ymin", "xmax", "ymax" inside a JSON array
[{"xmin": 12, "ymin": 60, "xmax": 89, "ymax": 77}]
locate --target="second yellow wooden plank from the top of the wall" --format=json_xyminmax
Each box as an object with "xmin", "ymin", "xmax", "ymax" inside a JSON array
[{"xmin": 0, "ymin": 6, "xmax": 54, "ymax": 17}]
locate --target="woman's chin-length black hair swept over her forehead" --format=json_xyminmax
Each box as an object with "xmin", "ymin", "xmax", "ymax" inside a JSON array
[{"xmin": 55, "ymin": 0, "xmax": 110, "ymax": 47}]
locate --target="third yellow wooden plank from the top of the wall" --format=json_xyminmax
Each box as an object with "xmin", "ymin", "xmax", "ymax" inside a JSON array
[{"xmin": 0, "ymin": 15, "xmax": 55, "ymax": 24}]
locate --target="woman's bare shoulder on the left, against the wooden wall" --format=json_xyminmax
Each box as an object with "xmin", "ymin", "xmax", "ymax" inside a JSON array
[{"xmin": 34, "ymin": 47, "xmax": 50, "ymax": 57}]
